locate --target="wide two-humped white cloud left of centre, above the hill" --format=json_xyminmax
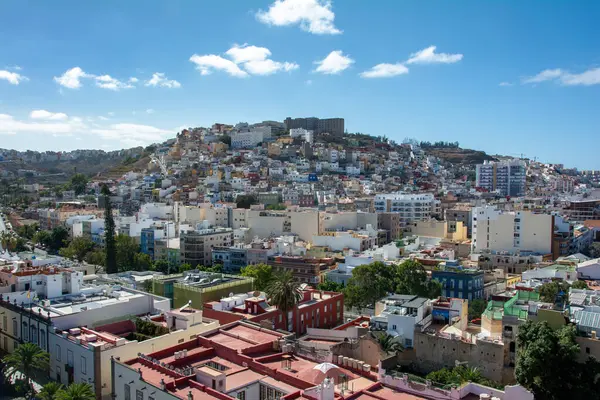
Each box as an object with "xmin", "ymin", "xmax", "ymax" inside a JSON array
[{"xmin": 190, "ymin": 43, "xmax": 299, "ymax": 78}]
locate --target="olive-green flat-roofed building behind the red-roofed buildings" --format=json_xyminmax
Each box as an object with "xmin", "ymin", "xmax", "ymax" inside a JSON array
[{"xmin": 152, "ymin": 271, "xmax": 254, "ymax": 310}]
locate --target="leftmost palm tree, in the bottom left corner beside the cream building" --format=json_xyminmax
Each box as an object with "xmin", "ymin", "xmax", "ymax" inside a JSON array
[{"xmin": 2, "ymin": 343, "xmax": 50, "ymax": 396}]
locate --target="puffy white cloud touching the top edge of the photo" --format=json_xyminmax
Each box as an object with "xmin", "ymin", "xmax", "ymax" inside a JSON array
[{"xmin": 256, "ymin": 0, "xmax": 342, "ymax": 35}]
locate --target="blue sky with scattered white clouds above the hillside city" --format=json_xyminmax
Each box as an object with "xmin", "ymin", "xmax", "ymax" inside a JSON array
[{"xmin": 0, "ymin": 0, "xmax": 600, "ymax": 169}]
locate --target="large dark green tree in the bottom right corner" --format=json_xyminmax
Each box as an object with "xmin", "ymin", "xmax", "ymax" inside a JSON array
[{"xmin": 515, "ymin": 320, "xmax": 600, "ymax": 400}]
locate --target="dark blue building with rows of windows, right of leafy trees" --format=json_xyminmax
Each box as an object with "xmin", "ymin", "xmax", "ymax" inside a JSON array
[{"xmin": 431, "ymin": 261, "xmax": 484, "ymax": 300}]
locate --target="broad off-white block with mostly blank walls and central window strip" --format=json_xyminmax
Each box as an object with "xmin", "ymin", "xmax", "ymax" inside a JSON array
[{"xmin": 471, "ymin": 206, "xmax": 554, "ymax": 254}]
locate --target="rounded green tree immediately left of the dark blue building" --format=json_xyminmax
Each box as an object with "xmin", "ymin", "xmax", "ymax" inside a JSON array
[{"xmin": 396, "ymin": 260, "xmax": 442, "ymax": 299}]
